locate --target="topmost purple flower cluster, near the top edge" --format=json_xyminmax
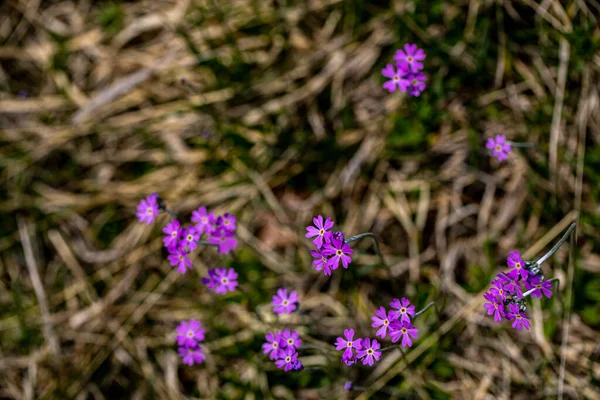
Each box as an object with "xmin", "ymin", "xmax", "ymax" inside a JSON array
[{"xmin": 381, "ymin": 43, "xmax": 426, "ymax": 96}]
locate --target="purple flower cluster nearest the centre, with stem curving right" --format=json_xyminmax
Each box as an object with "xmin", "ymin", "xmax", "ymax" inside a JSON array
[{"xmin": 305, "ymin": 215, "xmax": 354, "ymax": 275}]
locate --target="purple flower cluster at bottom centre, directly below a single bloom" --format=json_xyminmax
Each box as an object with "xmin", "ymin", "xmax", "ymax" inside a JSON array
[{"xmin": 262, "ymin": 329, "xmax": 303, "ymax": 372}]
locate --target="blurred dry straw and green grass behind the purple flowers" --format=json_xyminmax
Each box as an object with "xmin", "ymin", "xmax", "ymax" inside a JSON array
[{"xmin": 0, "ymin": 0, "xmax": 600, "ymax": 400}]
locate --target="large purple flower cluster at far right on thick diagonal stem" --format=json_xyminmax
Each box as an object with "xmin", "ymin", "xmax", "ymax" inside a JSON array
[{"xmin": 483, "ymin": 251, "xmax": 553, "ymax": 330}]
